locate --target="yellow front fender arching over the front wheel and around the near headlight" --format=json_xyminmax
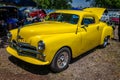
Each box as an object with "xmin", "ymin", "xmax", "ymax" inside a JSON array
[{"xmin": 30, "ymin": 33, "xmax": 82, "ymax": 63}]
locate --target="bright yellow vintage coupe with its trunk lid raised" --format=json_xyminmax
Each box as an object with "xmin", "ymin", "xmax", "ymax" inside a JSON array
[{"xmin": 7, "ymin": 8, "xmax": 113, "ymax": 72}]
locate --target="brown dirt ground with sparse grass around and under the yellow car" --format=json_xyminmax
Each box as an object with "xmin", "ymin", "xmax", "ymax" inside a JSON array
[{"xmin": 0, "ymin": 40, "xmax": 120, "ymax": 80}]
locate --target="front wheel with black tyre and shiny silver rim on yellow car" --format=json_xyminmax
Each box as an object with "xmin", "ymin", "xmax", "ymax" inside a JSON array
[{"xmin": 50, "ymin": 47, "xmax": 71, "ymax": 72}]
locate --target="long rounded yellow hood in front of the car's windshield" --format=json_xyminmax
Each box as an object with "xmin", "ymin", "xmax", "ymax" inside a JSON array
[{"xmin": 13, "ymin": 21, "xmax": 77, "ymax": 39}]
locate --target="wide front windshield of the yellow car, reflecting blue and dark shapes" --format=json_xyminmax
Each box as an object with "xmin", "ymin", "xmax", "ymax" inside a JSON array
[{"xmin": 47, "ymin": 13, "xmax": 79, "ymax": 24}]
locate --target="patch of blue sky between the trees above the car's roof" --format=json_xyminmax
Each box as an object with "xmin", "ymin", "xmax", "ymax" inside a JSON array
[{"xmin": 72, "ymin": 0, "xmax": 90, "ymax": 8}]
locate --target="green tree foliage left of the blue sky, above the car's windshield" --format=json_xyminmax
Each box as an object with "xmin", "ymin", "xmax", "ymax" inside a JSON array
[{"xmin": 34, "ymin": 0, "xmax": 72, "ymax": 9}]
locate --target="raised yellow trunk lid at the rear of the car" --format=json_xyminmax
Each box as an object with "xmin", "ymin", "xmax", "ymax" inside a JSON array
[{"xmin": 83, "ymin": 8, "xmax": 106, "ymax": 19}]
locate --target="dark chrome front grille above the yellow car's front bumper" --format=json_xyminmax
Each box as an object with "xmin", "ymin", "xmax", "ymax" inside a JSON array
[{"xmin": 10, "ymin": 40, "xmax": 45, "ymax": 61}]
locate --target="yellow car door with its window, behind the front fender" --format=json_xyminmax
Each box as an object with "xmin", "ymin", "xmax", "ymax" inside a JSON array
[{"xmin": 81, "ymin": 15, "xmax": 101, "ymax": 51}]
